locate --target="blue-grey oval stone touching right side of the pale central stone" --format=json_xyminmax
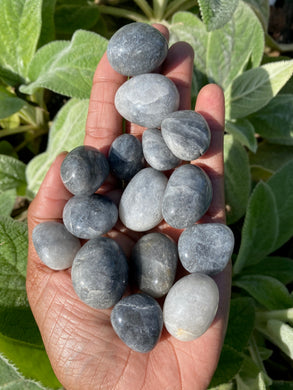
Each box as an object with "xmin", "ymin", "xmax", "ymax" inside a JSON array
[{"xmin": 162, "ymin": 164, "xmax": 213, "ymax": 229}]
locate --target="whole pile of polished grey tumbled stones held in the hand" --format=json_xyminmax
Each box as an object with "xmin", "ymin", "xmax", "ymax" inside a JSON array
[{"xmin": 33, "ymin": 23, "xmax": 234, "ymax": 352}]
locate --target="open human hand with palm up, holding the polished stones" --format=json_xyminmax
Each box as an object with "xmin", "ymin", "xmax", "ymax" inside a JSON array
[{"xmin": 27, "ymin": 25, "xmax": 231, "ymax": 390}]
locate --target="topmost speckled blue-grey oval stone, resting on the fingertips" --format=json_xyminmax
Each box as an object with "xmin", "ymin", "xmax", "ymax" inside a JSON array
[{"xmin": 107, "ymin": 22, "xmax": 168, "ymax": 76}]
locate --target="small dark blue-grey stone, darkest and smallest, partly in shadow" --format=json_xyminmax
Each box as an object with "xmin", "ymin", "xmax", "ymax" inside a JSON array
[{"xmin": 108, "ymin": 134, "xmax": 144, "ymax": 181}]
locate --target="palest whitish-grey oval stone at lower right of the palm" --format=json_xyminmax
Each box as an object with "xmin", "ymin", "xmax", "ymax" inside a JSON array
[{"xmin": 163, "ymin": 273, "xmax": 219, "ymax": 341}]
